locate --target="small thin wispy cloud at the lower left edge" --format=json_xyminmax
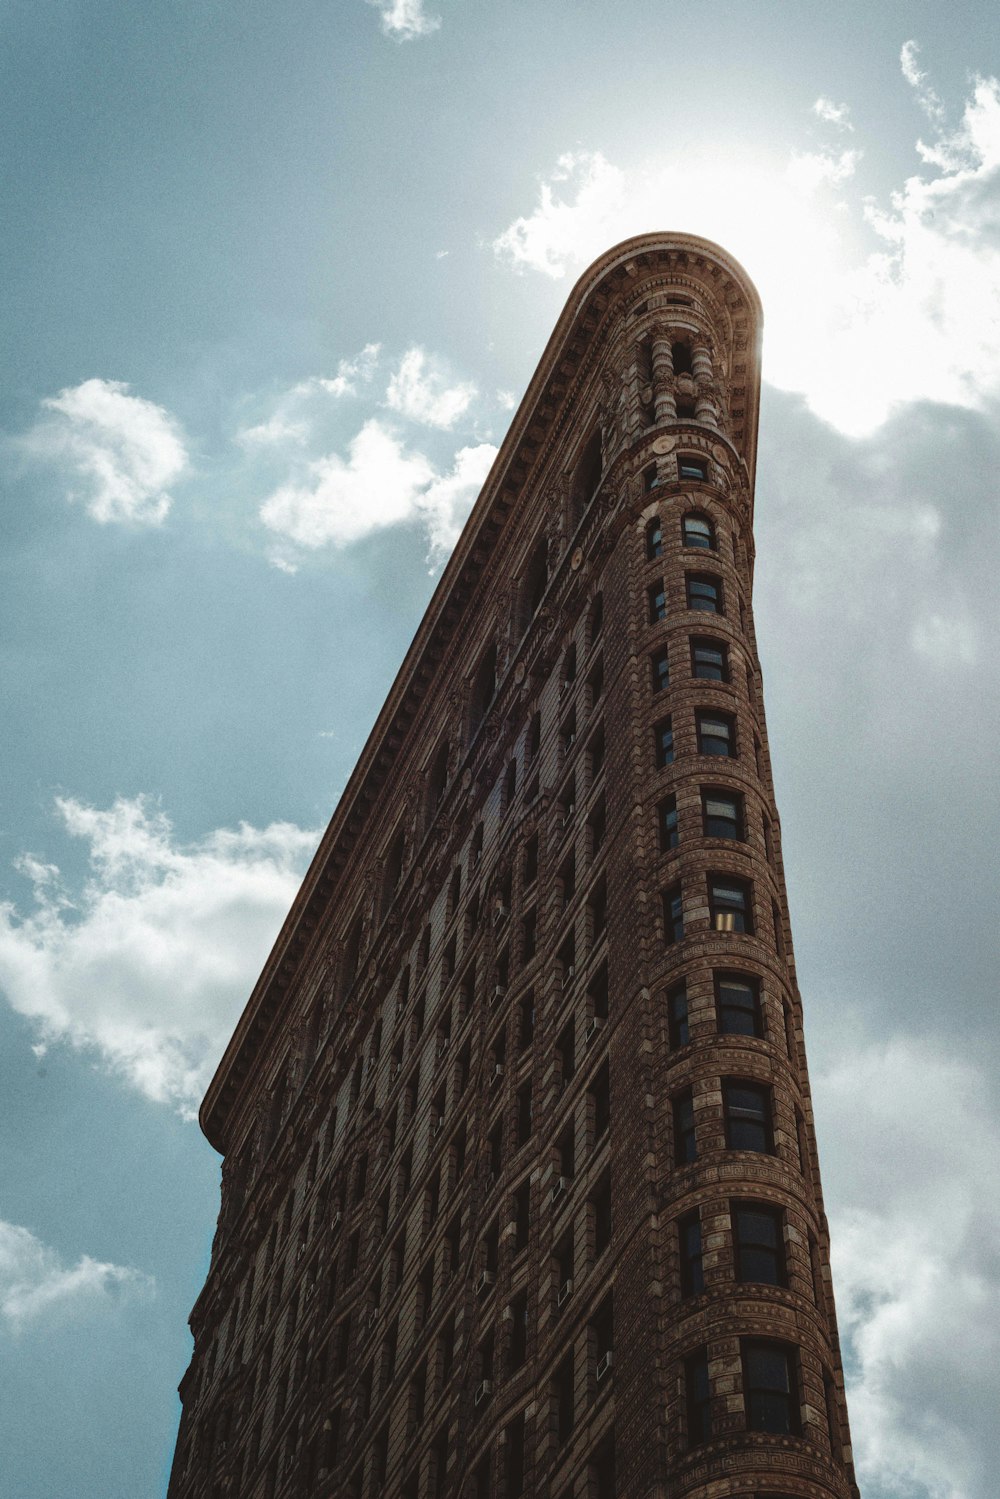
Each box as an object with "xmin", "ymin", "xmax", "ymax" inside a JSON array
[{"xmin": 0, "ymin": 1220, "xmax": 154, "ymax": 1333}]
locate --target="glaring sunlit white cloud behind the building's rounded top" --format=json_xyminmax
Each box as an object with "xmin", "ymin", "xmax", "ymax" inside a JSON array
[{"xmin": 493, "ymin": 65, "xmax": 1000, "ymax": 435}]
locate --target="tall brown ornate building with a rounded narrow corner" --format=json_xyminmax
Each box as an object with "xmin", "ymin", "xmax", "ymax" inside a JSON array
[{"xmin": 169, "ymin": 234, "xmax": 858, "ymax": 1499}]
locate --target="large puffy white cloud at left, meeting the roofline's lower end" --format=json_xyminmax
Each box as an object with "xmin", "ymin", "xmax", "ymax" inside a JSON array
[{"xmin": 0, "ymin": 797, "xmax": 318, "ymax": 1112}]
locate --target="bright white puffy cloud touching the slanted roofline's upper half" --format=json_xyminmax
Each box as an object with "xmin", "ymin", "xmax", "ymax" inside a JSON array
[{"xmin": 261, "ymin": 418, "xmax": 496, "ymax": 565}]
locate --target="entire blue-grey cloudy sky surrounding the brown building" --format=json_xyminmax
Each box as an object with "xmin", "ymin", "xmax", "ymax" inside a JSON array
[{"xmin": 0, "ymin": 0, "xmax": 1000, "ymax": 1499}]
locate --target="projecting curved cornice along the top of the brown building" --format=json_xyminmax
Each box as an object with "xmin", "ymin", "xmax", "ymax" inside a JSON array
[{"xmin": 199, "ymin": 232, "xmax": 762, "ymax": 1153}]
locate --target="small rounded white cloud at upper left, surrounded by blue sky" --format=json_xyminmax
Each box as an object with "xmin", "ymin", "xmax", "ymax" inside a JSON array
[{"xmin": 21, "ymin": 379, "xmax": 187, "ymax": 526}]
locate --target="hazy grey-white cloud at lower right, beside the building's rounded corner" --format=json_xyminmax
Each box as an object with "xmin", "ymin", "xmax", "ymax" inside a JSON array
[{"xmin": 816, "ymin": 1037, "xmax": 1000, "ymax": 1499}]
